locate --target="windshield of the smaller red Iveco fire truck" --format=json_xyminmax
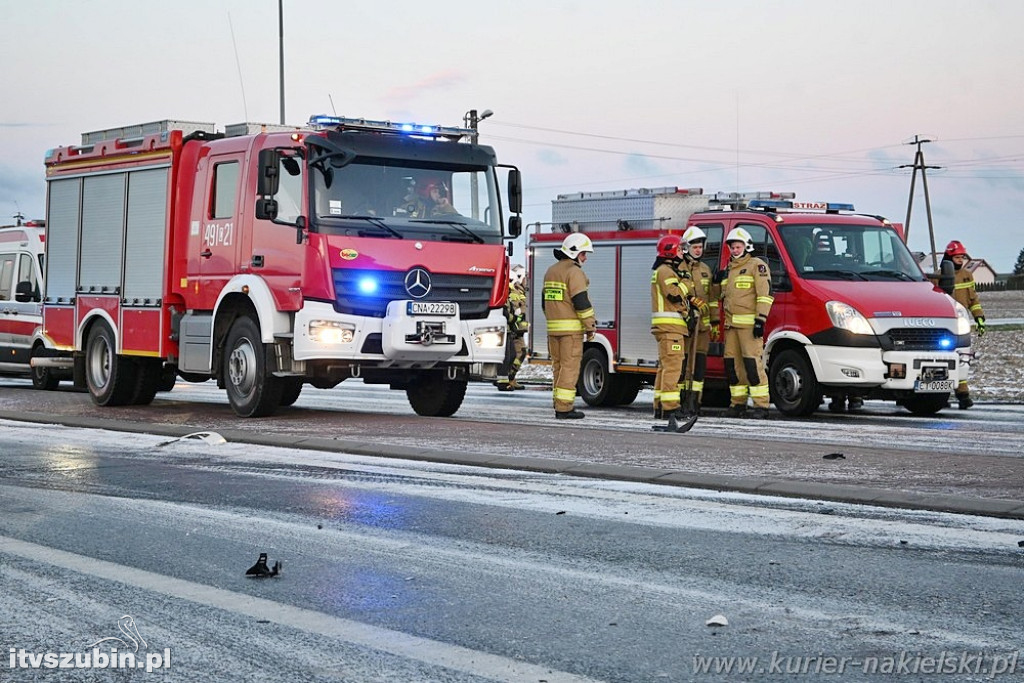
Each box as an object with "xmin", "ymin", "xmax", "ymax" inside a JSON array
[{"xmin": 779, "ymin": 223, "xmax": 925, "ymax": 282}]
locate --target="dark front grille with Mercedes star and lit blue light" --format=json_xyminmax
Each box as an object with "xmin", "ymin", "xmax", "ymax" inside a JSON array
[{"xmin": 334, "ymin": 268, "xmax": 495, "ymax": 319}]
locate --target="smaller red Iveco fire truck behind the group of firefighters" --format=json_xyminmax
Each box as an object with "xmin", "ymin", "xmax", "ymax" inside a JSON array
[{"xmin": 527, "ymin": 187, "xmax": 971, "ymax": 416}]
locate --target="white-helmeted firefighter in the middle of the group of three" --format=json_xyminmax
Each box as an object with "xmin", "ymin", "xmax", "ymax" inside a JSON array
[{"xmin": 679, "ymin": 225, "xmax": 718, "ymax": 414}]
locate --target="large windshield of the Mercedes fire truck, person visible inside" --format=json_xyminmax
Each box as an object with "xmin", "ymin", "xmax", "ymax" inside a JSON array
[{"xmin": 311, "ymin": 158, "xmax": 502, "ymax": 244}]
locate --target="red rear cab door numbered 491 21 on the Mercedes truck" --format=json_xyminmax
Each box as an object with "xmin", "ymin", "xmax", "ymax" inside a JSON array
[{"xmin": 188, "ymin": 153, "xmax": 244, "ymax": 310}]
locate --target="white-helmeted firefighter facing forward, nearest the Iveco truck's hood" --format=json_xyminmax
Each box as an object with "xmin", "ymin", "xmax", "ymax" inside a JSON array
[{"xmin": 720, "ymin": 227, "xmax": 774, "ymax": 420}]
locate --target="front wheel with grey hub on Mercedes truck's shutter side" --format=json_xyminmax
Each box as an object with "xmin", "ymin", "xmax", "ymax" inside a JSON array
[{"xmin": 221, "ymin": 316, "xmax": 282, "ymax": 418}]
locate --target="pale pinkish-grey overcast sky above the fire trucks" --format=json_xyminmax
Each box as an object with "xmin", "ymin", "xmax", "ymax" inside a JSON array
[{"xmin": 6, "ymin": 0, "xmax": 1024, "ymax": 272}]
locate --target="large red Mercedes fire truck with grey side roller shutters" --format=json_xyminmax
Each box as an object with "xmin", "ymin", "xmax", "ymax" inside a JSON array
[{"xmin": 35, "ymin": 117, "xmax": 522, "ymax": 417}]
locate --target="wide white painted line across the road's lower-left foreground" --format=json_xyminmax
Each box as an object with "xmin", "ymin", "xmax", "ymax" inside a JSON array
[{"xmin": 0, "ymin": 536, "xmax": 594, "ymax": 683}]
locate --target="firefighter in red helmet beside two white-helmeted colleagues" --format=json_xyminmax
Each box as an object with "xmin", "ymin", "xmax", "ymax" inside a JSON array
[{"xmin": 650, "ymin": 234, "xmax": 691, "ymax": 419}]
